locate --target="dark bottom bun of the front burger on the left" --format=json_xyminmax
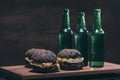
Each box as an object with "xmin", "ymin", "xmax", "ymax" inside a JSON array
[{"xmin": 32, "ymin": 65, "xmax": 59, "ymax": 73}]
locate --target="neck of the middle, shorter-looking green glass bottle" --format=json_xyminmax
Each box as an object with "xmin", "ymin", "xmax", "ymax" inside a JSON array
[{"xmin": 77, "ymin": 14, "xmax": 86, "ymax": 29}]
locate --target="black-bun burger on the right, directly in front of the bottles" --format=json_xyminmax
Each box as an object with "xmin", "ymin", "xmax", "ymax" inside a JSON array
[{"xmin": 57, "ymin": 49, "xmax": 84, "ymax": 70}]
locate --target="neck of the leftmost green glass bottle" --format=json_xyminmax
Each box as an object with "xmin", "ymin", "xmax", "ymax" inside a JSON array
[{"xmin": 62, "ymin": 10, "xmax": 70, "ymax": 29}]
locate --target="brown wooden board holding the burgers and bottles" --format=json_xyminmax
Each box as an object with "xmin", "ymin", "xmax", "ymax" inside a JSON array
[{"xmin": 0, "ymin": 62, "xmax": 120, "ymax": 80}]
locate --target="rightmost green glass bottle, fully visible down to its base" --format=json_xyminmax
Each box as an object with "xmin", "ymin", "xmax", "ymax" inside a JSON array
[{"xmin": 89, "ymin": 9, "xmax": 104, "ymax": 67}]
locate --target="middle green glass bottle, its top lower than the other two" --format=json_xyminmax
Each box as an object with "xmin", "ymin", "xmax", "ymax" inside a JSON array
[{"xmin": 74, "ymin": 12, "xmax": 89, "ymax": 66}]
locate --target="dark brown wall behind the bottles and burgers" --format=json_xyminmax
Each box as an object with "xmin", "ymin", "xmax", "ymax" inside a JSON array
[{"xmin": 0, "ymin": 0, "xmax": 120, "ymax": 66}]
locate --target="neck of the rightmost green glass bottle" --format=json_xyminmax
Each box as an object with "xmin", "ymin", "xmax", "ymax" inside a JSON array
[{"xmin": 93, "ymin": 12, "xmax": 102, "ymax": 30}]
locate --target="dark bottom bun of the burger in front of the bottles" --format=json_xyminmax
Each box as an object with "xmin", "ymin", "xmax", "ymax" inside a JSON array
[{"xmin": 59, "ymin": 62, "xmax": 82, "ymax": 70}]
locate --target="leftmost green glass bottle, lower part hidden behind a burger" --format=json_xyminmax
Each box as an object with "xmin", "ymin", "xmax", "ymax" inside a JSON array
[{"xmin": 58, "ymin": 9, "xmax": 73, "ymax": 51}]
